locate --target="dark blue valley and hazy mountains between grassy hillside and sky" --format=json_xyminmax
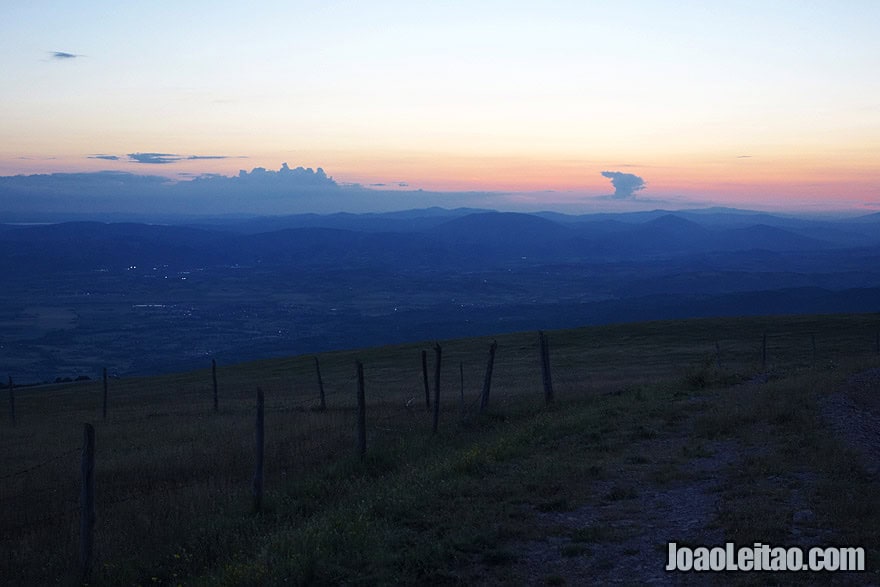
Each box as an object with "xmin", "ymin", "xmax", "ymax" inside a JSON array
[{"xmin": 0, "ymin": 208, "xmax": 880, "ymax": 379}]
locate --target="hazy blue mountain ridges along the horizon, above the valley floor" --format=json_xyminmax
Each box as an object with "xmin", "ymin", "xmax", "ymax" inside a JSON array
[{"xmin": 0, "ymin": 209, "xmax": 870, "ymax": 271}]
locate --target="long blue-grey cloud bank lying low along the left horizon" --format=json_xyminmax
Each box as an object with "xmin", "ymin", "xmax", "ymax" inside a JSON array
[{"xmin": 0, "ymin": 163, "xmax": 509, "ymax": 223}]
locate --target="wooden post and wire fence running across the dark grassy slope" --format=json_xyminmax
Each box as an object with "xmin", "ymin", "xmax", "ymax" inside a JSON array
[{"xmin": 0, "ymin": 320, "xmax": 880, "ymax": 579}]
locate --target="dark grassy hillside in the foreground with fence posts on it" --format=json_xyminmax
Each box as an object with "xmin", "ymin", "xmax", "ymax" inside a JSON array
[{"xmin": 0, "ymin": 315, "xmax": 880, "ymax": 585}]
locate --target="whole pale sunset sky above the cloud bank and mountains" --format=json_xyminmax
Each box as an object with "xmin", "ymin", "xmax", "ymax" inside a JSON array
[{"xmin": 0, "ymin": 0, "xmax": 880, "ymax": 210}]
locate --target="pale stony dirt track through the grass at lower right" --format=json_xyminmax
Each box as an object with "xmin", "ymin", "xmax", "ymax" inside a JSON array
[{"xmin": 512, "ymin": 369, "xmax": 880, "ymax": 585}]
